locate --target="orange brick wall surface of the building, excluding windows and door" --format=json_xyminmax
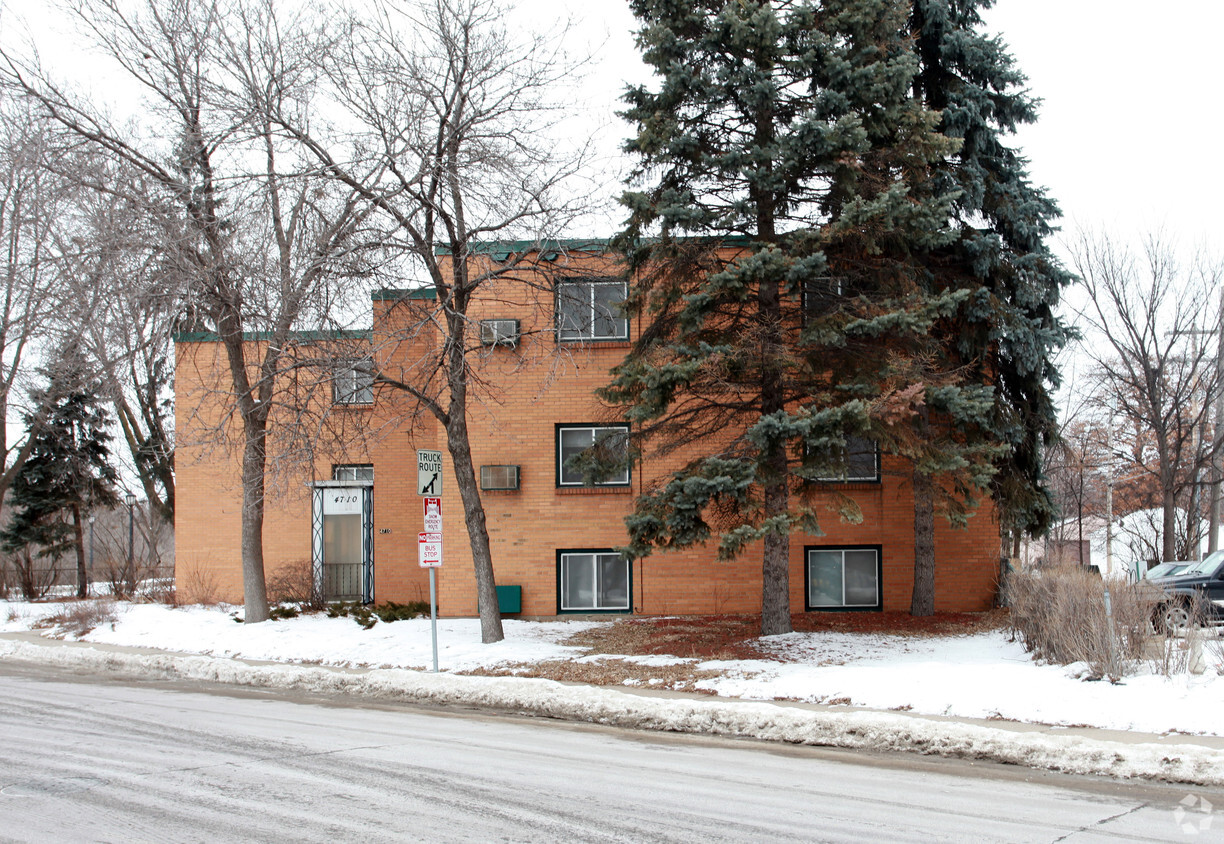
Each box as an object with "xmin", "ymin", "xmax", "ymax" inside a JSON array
[{"xmin": 176, "ymin": 258, "xmax": 999, "ymax": 616}]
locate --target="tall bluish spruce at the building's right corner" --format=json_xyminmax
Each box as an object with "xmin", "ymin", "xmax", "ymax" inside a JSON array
[{"xmin": 911, "ymin": 0, "xmax": 1071, "ymax": 615}]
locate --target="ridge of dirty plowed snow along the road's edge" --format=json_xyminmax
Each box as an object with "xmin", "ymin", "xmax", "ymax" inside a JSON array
[{"xmin": 7, "ymin": 634, "xmax": 1224, "ymax": 787}]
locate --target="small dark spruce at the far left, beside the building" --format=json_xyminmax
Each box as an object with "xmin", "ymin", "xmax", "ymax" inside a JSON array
[{"xmin": 0, "ymin": 351, "xmax": 119, "ymax": 598}]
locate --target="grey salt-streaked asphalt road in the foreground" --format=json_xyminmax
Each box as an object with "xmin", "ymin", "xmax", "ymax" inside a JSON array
[{"xmin": 0, "ymin": 662, "xmax": 1224, "ymax": 842}]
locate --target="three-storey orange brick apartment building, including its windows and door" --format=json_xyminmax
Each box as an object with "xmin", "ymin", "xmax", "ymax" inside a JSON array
[{"xmin": 175, "ymin": 242, "xmax": 1000, "ymax": 616}]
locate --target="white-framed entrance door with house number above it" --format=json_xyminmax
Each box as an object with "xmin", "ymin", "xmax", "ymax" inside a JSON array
[{"xmin": 311, "ymin": 481, "xmax": 375, "ymax": 603}]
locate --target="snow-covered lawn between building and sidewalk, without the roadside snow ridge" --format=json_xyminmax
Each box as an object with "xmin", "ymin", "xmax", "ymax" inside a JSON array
[{"xmin": 0, "ymin": 592, "xmax": 1224, "ymax": 735}]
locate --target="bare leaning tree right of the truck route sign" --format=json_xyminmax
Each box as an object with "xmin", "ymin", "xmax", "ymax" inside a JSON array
[{"xmin": 278, "ymin": 0, "xmax": 583, "ymax": 642}]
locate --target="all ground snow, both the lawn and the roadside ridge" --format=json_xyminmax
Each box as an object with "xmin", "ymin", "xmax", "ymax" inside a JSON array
[{"xmin": 7, "ymin": 602, "xmax": 1224, "ymax": 785}]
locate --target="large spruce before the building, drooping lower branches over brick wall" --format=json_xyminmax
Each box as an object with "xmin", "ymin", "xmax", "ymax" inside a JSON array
[{"xmin": 603, "ymin": 0, "xmax": 989, "ymax": 635}]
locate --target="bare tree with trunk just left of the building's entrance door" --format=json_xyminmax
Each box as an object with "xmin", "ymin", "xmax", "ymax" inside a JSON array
[{"xmin": 4, "ymin": 0, "xmax": 362, "ymax": 621}]
